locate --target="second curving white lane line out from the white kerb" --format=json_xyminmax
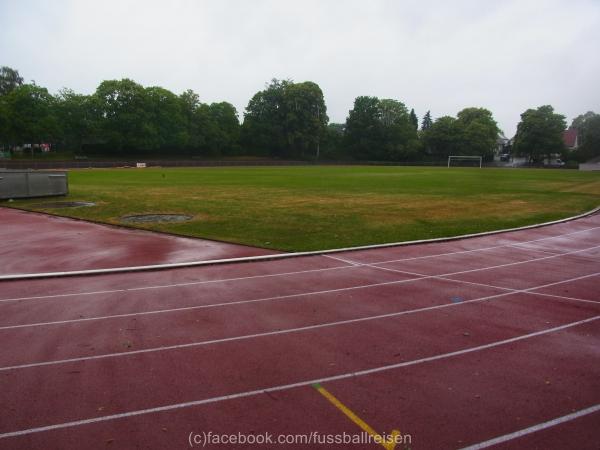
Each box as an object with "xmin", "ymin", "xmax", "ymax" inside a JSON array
[{"xmin": 0, "ymin": 245, "xmax": 600, "ymax": 330}]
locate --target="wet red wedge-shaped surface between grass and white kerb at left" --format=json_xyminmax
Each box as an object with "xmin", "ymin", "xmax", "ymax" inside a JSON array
[{"xmin": 0, "ymin": 207, "xmax": 276, "ymax": 275}]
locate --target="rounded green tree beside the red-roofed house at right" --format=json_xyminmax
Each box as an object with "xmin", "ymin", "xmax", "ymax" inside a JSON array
[{"xmin": 514, "ymin": 105, "xmax": 566, "ymax": 163}]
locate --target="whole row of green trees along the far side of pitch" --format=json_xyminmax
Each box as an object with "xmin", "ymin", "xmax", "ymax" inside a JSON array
[{"xmin": 0, "ymin": 67, "xmax": 600, "ymax": 162}]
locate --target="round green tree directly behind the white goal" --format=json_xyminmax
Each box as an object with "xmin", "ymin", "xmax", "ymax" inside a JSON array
[{"xmin": 456, "ymin": 108, "xmax": 500, "ymax": 160}]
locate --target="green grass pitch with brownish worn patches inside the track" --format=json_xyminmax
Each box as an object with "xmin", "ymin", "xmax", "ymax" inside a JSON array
[{"xmin": 10, "ymin": 166, "xmax": 600, "ymax": 251}]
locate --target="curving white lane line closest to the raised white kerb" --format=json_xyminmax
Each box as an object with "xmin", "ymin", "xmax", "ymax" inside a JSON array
[{"xmin": 0, "ymin": 226, "xmax": 600, "ymax": 303}]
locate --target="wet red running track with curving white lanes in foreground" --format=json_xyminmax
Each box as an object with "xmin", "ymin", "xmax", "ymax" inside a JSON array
[{"xmin": 0, "ymin": 209, "xmax": 600, "ymax": 449}]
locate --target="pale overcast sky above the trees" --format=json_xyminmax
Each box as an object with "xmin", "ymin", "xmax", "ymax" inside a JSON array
[{"xmin": 0, "ymin": 0, "xmax": 600, "ymax": 137}]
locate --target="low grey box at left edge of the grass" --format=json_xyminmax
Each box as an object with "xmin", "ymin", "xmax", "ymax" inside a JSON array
[{"xmin": 0, "ymin": 169, "xmax": 69, "ymax": 200}]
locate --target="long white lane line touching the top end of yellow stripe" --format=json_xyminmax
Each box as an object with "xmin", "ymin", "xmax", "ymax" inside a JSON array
[{"xmin": 0, "ymin": 316, "xmax": 600, "ymax": 439}]
